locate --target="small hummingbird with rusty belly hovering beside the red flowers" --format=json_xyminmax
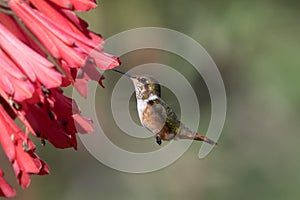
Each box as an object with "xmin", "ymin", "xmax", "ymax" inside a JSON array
[{"xmin": 113, "ymin": 69, "xmax": 217, "ymax": 145}]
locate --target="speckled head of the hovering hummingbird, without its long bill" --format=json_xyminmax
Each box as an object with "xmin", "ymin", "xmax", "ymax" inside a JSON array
[{"xmin": 130, "ymin": 76, "xmax": 160, "ymax": 100}]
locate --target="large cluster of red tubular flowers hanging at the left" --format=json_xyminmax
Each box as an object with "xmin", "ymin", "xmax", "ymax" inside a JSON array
[{"xmin": 0, "ymin": 0, "xmax": 120, "ymax": 197}]
